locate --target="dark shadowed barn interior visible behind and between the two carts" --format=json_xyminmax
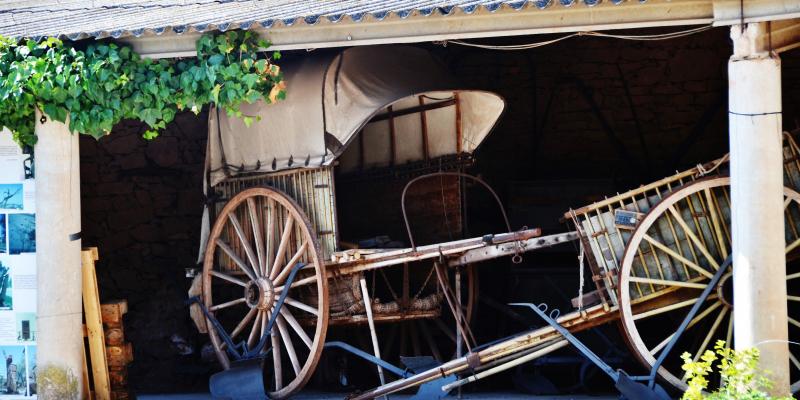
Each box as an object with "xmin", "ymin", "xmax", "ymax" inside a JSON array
[{"xmin": 75, "ymin": 28, "xmax": 800, "ymax": 394}]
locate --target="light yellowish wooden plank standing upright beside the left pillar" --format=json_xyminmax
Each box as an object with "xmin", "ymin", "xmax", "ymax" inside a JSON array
[{"xmin": 81, "ymin": 248, "xmax": 111, "ymax": 400}]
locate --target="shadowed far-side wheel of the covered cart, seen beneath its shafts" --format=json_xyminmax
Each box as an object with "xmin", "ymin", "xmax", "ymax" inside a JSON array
[{"xmin": 375, "ymin": 265, "xmax": 478, "ymax": 365}]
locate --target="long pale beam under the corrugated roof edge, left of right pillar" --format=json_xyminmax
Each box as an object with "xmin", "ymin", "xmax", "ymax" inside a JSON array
[{"xmin": 125, "ymin": 0, "xmax": 720, "ymax": 58}]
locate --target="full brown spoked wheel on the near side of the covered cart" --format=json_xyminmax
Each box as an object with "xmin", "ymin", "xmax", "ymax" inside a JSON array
[{"xmin": 203, "ymin": 188, "xmax": 328, "ymax": 398}]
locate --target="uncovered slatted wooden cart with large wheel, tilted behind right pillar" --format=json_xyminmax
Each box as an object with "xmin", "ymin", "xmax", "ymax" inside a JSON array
[{"xmin": 565, "ymin": 133, "xmax": 800, "ymax": 392}]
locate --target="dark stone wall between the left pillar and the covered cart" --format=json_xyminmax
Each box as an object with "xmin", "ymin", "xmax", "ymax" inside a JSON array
[{"xmin": 81, "ymin": 113, "xmax": 209, "ymax": 392}]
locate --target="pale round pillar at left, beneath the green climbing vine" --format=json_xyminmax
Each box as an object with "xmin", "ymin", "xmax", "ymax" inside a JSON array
[{"xmin": 34, "ymin": 111, "xmax": 84, "ymax": 400}]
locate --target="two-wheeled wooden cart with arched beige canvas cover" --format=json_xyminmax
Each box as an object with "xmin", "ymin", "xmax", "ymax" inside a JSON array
[{"xmin": 195, "ymin": 47, "xmax": 544, "ymax": 398}]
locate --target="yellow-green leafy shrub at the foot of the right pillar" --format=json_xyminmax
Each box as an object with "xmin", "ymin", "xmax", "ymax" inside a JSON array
[{"xmin": 681, "ymin": 340, "xmax": 793, "ymax": 400}]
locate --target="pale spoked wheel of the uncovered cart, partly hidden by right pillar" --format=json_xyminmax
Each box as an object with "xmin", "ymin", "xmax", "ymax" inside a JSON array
[{"xmin": 619, "ymin": 177, "xmax": 800, "ymax": 392}]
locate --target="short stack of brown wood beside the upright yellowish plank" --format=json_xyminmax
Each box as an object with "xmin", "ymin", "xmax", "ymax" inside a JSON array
[{"xmin": 100, "ymin": 300, "xmax": 133, "ymax": 400}]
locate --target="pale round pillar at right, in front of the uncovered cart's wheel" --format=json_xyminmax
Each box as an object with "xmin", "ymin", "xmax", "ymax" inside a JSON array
[{"xmin": 728, "ymin": 24, "xmax": 790, "ymax": 396}]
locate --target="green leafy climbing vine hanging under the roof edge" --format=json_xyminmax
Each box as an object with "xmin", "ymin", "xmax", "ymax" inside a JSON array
[{"xmin": 0, "ymin": 31, "xmax": 285, "ymax": 145}]
